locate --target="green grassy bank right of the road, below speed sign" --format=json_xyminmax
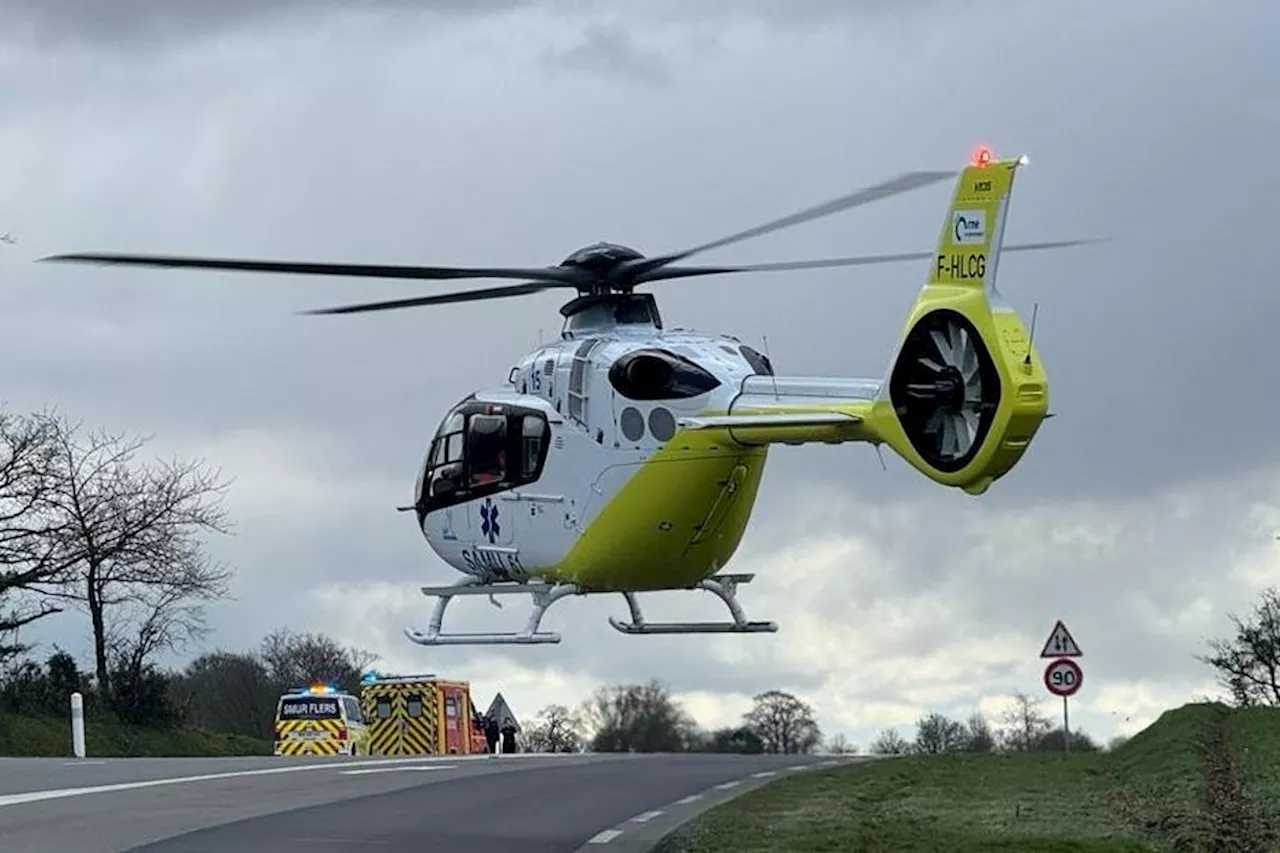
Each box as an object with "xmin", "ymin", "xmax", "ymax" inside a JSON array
[{"xmin": 663, "ymin": 704, "xmax": 1280, "ymax": 853}]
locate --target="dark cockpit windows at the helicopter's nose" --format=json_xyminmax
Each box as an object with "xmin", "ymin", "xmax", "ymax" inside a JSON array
[{"xmin": 417, "ymin": 400, "xmax": 549, "ymax": 512}]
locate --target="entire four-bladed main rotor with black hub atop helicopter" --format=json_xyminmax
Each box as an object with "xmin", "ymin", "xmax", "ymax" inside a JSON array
[{"xmin": 41, "ymin": 159, "xmax": 1094, "ymax": 314}]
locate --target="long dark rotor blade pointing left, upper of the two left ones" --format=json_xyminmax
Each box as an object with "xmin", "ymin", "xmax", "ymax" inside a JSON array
[{"xmin": 41, "ymin": 252, "xmax": 580, "ymax": 287}]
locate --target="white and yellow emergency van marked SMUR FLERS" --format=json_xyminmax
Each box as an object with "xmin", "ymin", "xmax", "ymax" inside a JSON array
[{"xmin": 274, "ymin": 684, "xmax": 370, "ymax": 756}]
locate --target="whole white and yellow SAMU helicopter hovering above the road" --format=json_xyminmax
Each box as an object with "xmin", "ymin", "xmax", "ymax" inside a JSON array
[{"xmin": 42, "ymin": 146, "xmax": 1096, "ymax": 646}]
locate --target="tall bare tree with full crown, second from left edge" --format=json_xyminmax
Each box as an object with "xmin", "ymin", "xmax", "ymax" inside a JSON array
[{"xmin": 36, "ymin": 420, "xmax": 230, "ymax": 694}]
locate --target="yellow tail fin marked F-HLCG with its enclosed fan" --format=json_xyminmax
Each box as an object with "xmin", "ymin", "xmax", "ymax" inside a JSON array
[{"xmin": 865, "ymin": 154, "xmax": 1048, "ymax": 494}]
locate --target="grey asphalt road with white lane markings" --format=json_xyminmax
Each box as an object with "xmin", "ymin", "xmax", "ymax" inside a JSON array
[{"xmin": 0, "ymin": 754, "xmax": 865, "ymax": 853}]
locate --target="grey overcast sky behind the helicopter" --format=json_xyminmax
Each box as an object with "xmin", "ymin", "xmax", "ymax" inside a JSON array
[{"xmin": 0, "ymin": 0, "xmax": 1280, "ymax": 744}]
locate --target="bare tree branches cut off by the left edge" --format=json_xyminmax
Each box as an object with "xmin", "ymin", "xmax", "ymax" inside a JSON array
[{"xmin": 0, "ymin": 411, "xmax": 74, "ymax": 662}]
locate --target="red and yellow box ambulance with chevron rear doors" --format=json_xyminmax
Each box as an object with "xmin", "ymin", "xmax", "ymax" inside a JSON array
[{"xmin": 360, "ymin": 672, "xmax": 486, "ymax": 756}]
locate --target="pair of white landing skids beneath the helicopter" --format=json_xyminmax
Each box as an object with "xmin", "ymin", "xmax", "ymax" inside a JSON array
[{"xmin": 404, "ymin": 575, "xmax": 778, "ymax": 646}]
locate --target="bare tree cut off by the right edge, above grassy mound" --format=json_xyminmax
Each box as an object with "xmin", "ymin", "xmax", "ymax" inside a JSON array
[{"xmin": 1197, "ymin": 587, "xmax": 1280, "ymax": 707}]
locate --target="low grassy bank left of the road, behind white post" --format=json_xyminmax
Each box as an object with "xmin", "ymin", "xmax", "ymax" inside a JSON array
[{"xmin": 0, "ymin": 713, "xmax": 271, "ymax": 758}]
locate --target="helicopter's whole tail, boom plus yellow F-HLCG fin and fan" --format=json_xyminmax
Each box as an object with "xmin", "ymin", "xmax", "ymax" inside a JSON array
[{"xmin": 680, "ymin": 151, "xmax": 1048, "ymax": 494}]
